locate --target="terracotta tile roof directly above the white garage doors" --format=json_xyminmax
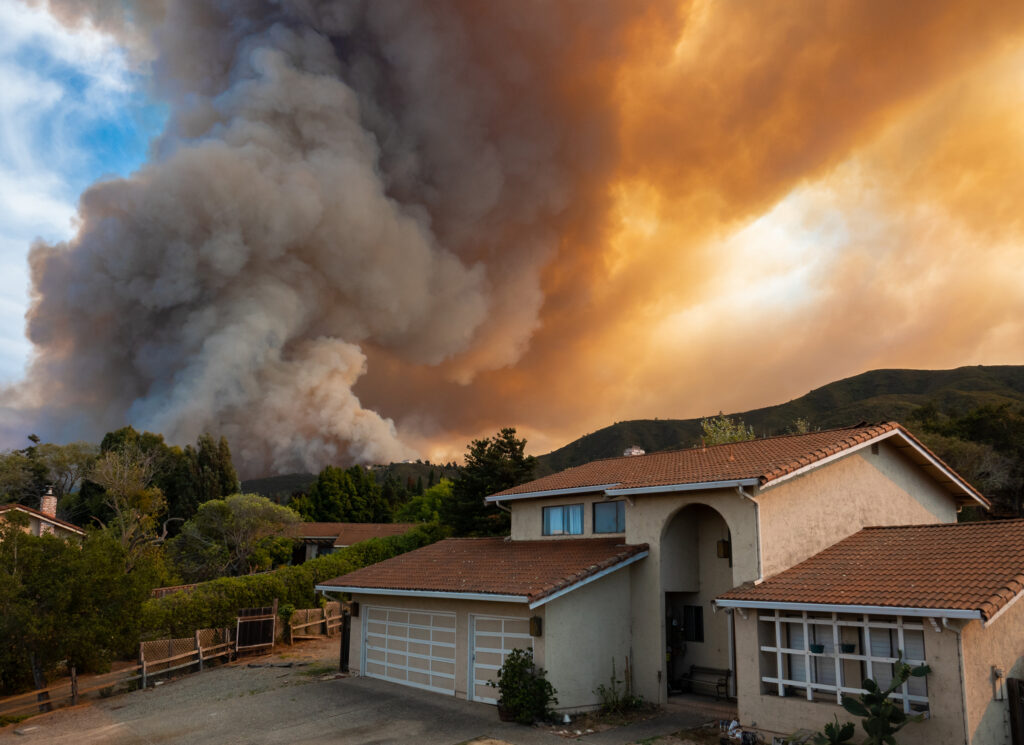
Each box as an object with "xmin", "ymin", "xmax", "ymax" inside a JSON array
[{"xmin": 317, "ymin": 538, "xmax": 647, "ymax": 603}]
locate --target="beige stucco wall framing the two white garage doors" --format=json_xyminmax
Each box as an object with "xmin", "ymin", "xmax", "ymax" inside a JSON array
[{"xmin": 348, "ymin": 594, "xmax": 548, "ymax": 699}]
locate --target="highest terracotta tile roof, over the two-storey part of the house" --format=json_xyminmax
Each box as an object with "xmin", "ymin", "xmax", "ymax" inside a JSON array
[{"xmin": 494, "ymin": 422, "xmax": 988, "ymax": 506}]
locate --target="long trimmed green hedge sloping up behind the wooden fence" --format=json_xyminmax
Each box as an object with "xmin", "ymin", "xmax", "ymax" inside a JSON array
[{"xmin": 141, "ymin": 523, "xmax": 445, "ymax": 640}]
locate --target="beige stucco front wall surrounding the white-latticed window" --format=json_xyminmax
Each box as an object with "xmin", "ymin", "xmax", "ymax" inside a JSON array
[{"xmin": 735, "ymin": 610, "xmax": 962, "ymax": 745}]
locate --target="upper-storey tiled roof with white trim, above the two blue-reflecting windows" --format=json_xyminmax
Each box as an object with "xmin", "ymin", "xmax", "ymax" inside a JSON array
[{"xmin": 487, "ymin": 422, "xmax": 989, "ymax": 507}]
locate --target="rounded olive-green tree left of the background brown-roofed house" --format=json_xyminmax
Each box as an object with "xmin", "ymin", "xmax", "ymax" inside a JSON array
[{"xmin": 167, "ymin": 494, "xmax": 299, "ymax": 581}]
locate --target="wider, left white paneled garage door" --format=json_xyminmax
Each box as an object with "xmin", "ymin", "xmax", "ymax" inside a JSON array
[{"xmin": 362, "ymin": 607, "xmax": 455, "ymax": 696}]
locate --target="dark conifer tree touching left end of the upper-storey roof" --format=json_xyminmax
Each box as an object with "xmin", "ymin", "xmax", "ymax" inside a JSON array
[{"xmin": 441, "ymin": 427, "xmax": 536, "ymax": 535}]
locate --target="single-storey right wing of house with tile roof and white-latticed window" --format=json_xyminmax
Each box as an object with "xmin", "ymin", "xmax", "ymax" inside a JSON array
[{"xmin": 716, "ymin": 520, "xmax": 1024, "ymax": 745}]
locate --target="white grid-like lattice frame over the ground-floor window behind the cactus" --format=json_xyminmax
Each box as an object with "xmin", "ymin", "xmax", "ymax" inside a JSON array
[{"xmin": 758, "ymin": 610, "xmax": 930, "ymax": 713}]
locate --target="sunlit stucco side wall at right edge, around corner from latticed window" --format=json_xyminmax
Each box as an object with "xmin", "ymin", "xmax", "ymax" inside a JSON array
[{"xmin": 963, "ymin": 601, "xmax": 1024, "ymax": 745}]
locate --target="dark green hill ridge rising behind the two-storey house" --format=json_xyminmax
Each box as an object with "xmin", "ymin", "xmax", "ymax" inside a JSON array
[{"xmin": 537, "ymin": 365, "xmax": 1024, "ymax": 477}]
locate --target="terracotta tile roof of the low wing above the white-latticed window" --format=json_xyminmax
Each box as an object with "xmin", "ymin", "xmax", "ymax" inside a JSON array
[{"xmin": 720, "ymin": 520, "xmax": 1024, "ymax": 619}]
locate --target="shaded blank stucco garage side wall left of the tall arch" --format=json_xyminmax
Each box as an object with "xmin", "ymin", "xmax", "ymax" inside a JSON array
[{"xmin": 539, "ymin": 559, "xmax": 630, "ymax": 710}]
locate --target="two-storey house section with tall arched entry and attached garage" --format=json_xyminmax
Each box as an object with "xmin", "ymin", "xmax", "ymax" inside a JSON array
[{"xmin": 317, "ymin": 423, "xmax": 988, "ymax": 721}]
